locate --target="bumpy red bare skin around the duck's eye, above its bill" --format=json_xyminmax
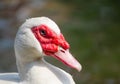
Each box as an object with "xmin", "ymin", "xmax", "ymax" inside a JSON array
[{"xmin": 32, "ymin": 25, "xmax": 70, "ymax": 55}]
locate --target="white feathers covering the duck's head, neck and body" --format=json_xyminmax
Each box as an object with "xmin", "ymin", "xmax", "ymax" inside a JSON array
[{"xmin": 0, "ymin": 17, "xmax": 81, "ymax": 84}]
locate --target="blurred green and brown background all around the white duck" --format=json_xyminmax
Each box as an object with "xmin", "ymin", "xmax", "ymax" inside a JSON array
[{"xmin": 0, "ymin": 0, "xmax": 120, "ymax": 84}]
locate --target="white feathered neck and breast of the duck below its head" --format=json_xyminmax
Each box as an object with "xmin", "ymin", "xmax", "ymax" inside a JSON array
[{"xmin": 17, "ymin": 56, "xmax": 74, "ymax": 84}]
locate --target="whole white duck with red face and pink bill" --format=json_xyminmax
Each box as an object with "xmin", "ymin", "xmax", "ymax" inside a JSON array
[{"xmin": 0, "ymin": 17, "xmax": 81, "ymax": 84}]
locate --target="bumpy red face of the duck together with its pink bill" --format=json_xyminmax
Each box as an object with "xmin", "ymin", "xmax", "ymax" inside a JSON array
[{"xmin": 32, "ymin": 25, "xmax": 81, "ymax": 71}]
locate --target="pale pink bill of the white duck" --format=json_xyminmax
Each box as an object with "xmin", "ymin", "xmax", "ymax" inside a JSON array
[{"xmin": 52, "ymin": 49, "xmax": 82, "ymax": 71}]
